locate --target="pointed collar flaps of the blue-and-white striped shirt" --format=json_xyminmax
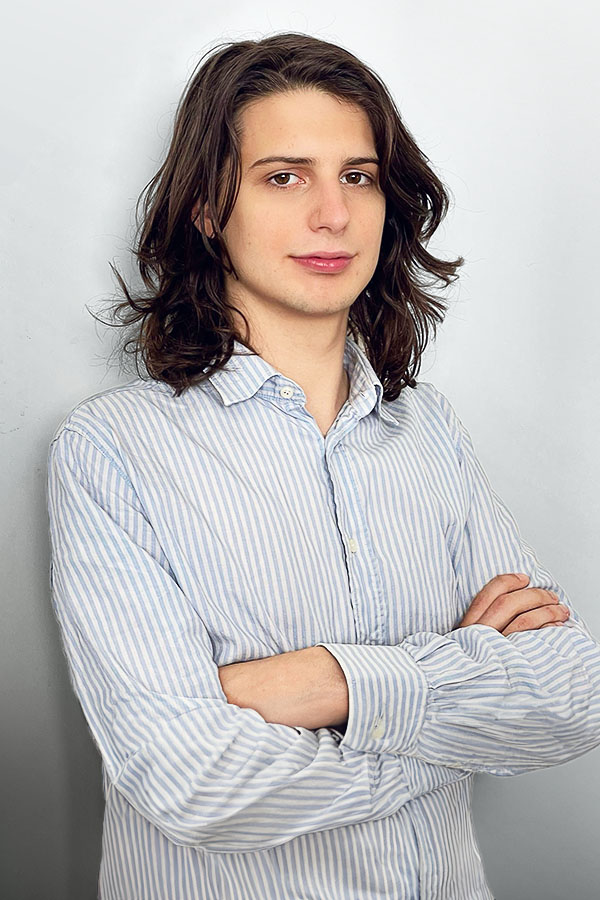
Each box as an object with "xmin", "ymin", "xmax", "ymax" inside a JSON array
[{"xmin": 208, "ymin": 336, "xmax": 396, "ymax": 422}]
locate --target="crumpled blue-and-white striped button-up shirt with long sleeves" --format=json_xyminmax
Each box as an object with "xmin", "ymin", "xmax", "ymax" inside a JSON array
[{"xmin": 48, "ymin": 337, "xmax": 600, "ymax": 900}]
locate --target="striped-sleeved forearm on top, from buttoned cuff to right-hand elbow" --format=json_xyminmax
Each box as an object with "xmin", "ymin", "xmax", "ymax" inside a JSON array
[{"xmin": 316, "ymin": 610, "xmax": 600, "ymax": 775}]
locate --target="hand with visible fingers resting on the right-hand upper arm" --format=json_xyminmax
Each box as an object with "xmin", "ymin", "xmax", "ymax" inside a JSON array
[{"xmin": 457, "ymin": 574, "xmax": 570, "ymax": 635}]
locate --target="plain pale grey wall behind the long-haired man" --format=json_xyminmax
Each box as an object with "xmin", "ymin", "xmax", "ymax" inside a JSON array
[{"xmin": 0, "ymin": 0, "xmax": 600, "ymax": 900}]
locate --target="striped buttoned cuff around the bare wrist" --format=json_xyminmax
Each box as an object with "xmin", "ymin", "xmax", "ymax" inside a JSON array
[{"xmin": 316, "ymin": 643, "xmax": 429, "ymax": 753}]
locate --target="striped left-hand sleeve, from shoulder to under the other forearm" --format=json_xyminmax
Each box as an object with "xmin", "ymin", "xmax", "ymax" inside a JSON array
[{"xmin": 48, "ymin": 426, "xmax": 470, "ymax": 852}]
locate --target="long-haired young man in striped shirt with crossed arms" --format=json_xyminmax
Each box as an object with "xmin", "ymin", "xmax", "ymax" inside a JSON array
[{"xmin": 49, "ymin": 34, "xmax": 600, "ymax": 900}]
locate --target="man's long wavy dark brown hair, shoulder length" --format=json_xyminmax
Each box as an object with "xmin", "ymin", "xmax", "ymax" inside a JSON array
[{"xmin": 105, "ymin": 33, "xmax": 464, "ymax": 400}]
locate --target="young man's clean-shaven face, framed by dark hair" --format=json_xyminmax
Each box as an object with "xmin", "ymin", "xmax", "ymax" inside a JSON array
[{"xmin": 204, "ymin": 90, "xmax": 385, "ymax": 336}]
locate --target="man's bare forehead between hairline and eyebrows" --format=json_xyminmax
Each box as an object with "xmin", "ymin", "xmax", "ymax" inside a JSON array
[{"xmin": 234, "ymin": 89, "xmax": 375, "ymax": 163}]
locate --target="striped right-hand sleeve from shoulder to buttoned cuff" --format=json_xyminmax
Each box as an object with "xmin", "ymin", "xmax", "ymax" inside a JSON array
[{"xmin": 318, "ymin": 385, "xmax": 600, "ymax": 775}]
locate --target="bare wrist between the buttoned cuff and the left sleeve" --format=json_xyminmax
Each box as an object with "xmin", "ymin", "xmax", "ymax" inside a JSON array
[{"xmin": 219, "ymin": 647, "xmax": 348, "ymax": 729}]
